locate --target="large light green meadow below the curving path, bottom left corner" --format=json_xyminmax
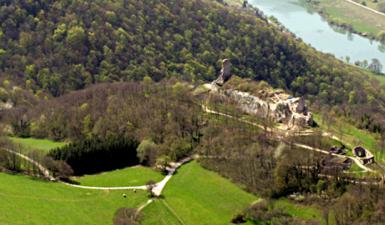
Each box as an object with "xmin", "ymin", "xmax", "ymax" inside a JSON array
[{"xmin": 0, "ymin": 173, "xmax": 147, "ymax": 225}]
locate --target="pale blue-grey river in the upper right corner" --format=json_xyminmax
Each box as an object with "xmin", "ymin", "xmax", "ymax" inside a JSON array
[{"xmin": 248, "ymin": 0, "xmax": 385, "ymax": 69}]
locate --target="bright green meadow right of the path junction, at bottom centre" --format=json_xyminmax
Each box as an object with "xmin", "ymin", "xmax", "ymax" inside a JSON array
[{"xmin": 143, "ymin": 161, "xmax": 258, "ymax": 225}]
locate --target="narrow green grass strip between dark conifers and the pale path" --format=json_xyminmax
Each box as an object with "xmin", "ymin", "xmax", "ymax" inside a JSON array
[{"xmin": 73, "ymin": 166, "xmax": 163, "ymax": 187}]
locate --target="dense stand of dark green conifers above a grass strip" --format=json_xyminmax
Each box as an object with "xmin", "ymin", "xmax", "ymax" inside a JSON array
[{"xmin": 48, "ymin": 136, "xmax": 139, "ymax": 175}]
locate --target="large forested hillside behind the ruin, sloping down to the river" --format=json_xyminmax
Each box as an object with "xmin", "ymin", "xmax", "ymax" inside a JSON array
[{"xmin": 0, "ymin": 0, "xmax": 385, "ymax": 132}]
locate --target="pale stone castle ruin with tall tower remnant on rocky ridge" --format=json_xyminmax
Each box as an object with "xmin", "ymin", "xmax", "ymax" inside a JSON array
[{"xmin": 209, "ymin": 59, "xmax": 314, "ymax": 129}]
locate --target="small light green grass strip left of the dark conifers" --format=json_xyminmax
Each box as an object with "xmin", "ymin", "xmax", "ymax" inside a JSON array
[{"xmin": 9, "ymin": 137, "xmax": 67, "ymax": 152}]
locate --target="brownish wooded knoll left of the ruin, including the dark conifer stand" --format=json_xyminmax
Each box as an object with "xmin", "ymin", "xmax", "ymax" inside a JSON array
[{"xmin": 3, "ymin": 80, "xmax": 203, "ymax": 169}]
